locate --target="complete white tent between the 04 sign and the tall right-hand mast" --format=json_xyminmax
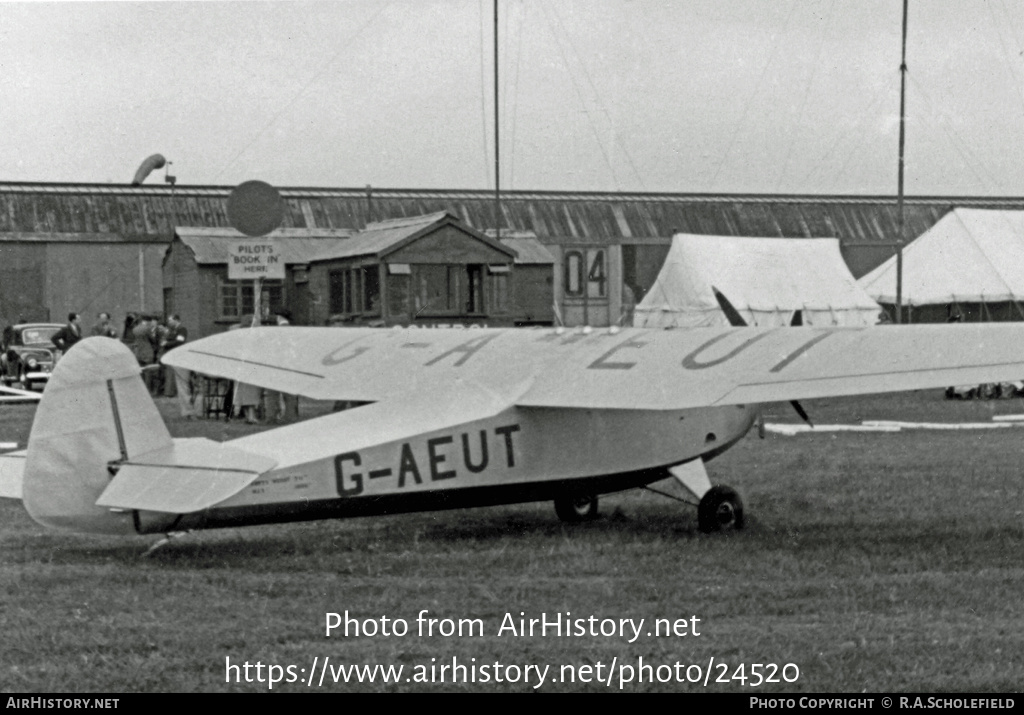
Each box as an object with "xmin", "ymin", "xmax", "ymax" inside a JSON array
[{"xmin": 633, "ymin": 234, "xmax": 881, "ymax": 328}]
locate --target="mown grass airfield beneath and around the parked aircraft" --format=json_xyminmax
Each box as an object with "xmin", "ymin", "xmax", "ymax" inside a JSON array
[{"xmin": 0, "ymin": 390, "xmax": 1024, "ymax": 695}]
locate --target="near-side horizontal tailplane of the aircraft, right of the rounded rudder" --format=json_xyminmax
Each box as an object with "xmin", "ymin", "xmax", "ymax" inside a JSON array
[{"xmin": 96, "ymin": 438, "xmax": 276, "ymax": 514}]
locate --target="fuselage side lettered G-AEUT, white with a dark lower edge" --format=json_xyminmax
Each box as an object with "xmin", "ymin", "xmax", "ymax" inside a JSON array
[{"xmin": 134, "ymin": 406, "xmax": 757, "ymax": 534}]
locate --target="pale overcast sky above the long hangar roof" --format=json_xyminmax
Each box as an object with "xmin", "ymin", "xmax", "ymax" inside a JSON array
[{"xmin": 0, "ymin": 0, "xmax": 1024, "ymax": 196}]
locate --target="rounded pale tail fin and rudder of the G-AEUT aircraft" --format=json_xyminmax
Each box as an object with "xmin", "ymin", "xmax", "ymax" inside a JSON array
[{"xmin": 22, "ymin": 337, "xmax": 173, "ymax": 534}]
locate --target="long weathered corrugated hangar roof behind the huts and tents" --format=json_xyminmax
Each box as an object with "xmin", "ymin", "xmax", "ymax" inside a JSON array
[{"xmin": 6, "ymin": 182, "xmax": 1024, "ymax": 275}]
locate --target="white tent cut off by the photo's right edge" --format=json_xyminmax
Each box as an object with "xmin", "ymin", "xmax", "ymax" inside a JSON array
[{"xmin": 858, "ymin": 204, "xmax": 1024, "ymax": 306}]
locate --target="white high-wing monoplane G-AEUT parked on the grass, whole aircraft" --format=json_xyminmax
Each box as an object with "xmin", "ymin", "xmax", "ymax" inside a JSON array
[{"xmin": 0, "ymin": 324, "xmax": 1024, "ymax": 534}]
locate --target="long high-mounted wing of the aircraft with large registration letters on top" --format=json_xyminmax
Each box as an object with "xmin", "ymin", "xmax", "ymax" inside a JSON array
[{"xmin": 165, "ymin": 324, "xmax": 1024, "ymax": 410}]
